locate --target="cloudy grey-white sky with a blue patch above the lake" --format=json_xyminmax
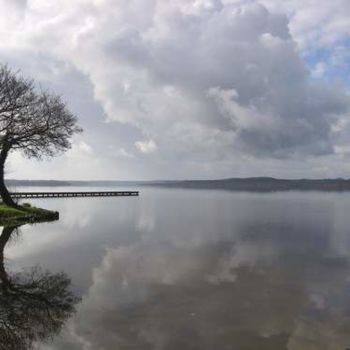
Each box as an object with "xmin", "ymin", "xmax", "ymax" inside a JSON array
[{"xmin": 0, "ymin": 0, "xmax": 350, "ymax": 180}]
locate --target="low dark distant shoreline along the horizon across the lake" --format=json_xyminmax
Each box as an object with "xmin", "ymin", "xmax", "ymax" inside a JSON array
[{"xmin": 6, "ymin": 177, "xmax": 350, "ymax": 192}]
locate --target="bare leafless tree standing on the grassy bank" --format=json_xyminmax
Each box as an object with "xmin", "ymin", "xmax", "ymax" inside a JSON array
[{"xmin": 0, "ymin": 65, "xmax": 82, "ymax": 206}]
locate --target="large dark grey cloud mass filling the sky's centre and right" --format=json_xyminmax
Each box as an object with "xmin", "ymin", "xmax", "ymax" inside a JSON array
[{"xmin": 73, "ymin": 1, "xmax": 349, "ymax": 159}]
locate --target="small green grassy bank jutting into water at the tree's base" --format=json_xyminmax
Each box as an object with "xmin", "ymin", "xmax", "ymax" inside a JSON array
[{"xmin": 0, "ymin": 203, "xmax": 59, "ymax": 226}]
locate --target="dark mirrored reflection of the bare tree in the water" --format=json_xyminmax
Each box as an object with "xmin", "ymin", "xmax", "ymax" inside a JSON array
[{"xmin": 0, "ymin": 226, "xmax": 78, "ymax": 350}]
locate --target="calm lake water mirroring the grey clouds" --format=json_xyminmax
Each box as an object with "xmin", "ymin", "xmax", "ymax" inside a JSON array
[{"xmin": 0, "ymin": 188, "xmax": 350, "ymax": 350}]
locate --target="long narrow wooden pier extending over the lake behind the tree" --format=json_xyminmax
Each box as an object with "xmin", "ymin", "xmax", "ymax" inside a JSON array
[{"xmin": 11, "ymin": 191, "xmax": 139, "ymax": 199}]
